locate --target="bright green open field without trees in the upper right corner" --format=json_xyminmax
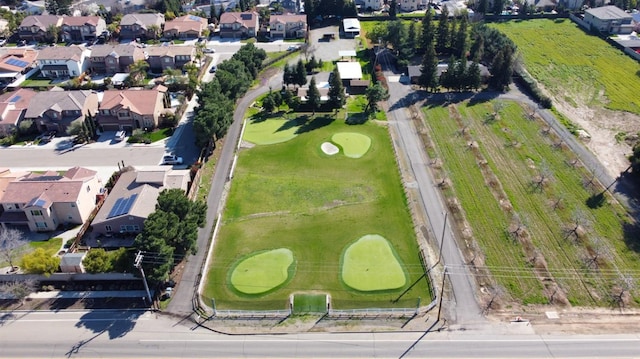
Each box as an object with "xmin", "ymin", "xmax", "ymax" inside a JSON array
[{"xmin": 489, "ymin": 19, "xmax": 640, "ymax": 114}]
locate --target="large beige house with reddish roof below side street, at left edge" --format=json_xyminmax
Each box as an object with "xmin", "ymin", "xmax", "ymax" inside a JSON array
[{"xmin": 0, "ymin": 167, "xmax": 102, "ymax": 232}]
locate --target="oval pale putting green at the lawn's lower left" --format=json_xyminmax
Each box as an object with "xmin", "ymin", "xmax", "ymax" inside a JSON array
[{"xmin": 231, "ymin": 248, "xmax": 294, "ymax": 294}]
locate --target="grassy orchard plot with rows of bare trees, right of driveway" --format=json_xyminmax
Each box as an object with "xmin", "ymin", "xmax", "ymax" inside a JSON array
[{"xmin": 424, "ymin": 100, "xmax": 640, "ymax": 306}]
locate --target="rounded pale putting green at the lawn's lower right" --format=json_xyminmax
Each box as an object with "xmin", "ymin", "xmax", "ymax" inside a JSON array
[{"xmin": 342, "ymin": 234, "xmax": 407, "ymax": 292}]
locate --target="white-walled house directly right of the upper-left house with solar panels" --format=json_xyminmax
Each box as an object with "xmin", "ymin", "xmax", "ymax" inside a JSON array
[{"xmin": 36, "ymin": 45, "xmax": 91, "ymax": 79}]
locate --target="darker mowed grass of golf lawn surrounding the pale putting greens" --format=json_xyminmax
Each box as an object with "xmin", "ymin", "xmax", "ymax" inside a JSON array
[{"xmin": 204, "ymin": 113, "xmax": 430, "ymax": 309}]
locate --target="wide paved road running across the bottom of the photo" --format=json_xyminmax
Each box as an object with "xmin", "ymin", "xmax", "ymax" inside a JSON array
[{"xmin": 0, "ymin": 311, "xmax": 640, "ymax": 358}]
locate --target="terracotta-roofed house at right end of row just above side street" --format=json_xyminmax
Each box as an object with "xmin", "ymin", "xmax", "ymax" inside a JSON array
[{"xmin": 96, "ymin": 86, "xmax": 167, "ymax": 131}]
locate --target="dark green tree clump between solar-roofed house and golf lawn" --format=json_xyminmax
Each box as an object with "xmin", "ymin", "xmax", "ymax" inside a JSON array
[{"xmin": 134, "ymin": 189, "xmax": 207, "ymax": 282}]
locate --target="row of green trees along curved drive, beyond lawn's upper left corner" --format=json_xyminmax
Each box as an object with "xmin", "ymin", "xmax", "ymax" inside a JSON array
[{"xmin": 193, "ymin": 44, "xmax": 267, "ymax": 147}]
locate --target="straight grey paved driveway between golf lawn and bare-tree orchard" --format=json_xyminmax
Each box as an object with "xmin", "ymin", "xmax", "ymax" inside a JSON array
[{"xmin": 378, "ymin": 53, "xmax": 485, "ymax": 327}]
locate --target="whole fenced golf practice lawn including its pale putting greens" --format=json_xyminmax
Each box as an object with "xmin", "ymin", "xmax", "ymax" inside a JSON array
[{"xmin": 204, "ymin": 100, "xmax": 431, "ymax": 309}]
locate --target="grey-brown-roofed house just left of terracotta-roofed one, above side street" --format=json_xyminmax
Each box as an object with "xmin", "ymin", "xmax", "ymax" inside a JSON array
[{"xmin": 24, "ymin": 87, "xmax": 98, "ymax": 133}]
